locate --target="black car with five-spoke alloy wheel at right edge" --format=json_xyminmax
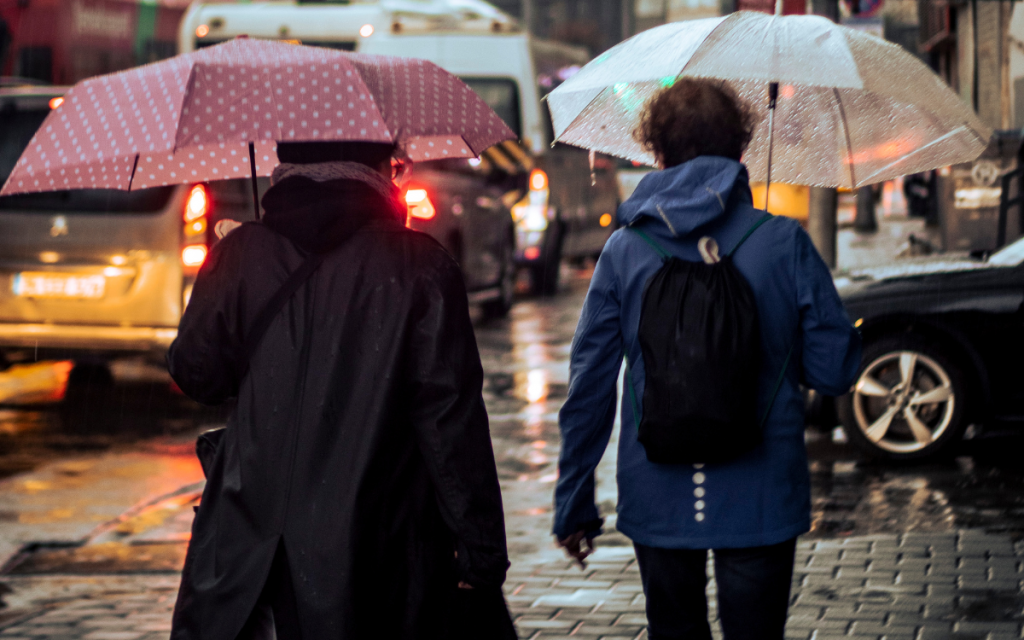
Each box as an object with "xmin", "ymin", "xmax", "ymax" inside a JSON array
[{"xmin": 836, "ymin": 239, "xmax": 1024, "ymax": 460}]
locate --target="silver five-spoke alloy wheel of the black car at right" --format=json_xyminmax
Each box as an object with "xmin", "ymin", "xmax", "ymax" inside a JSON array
[{"xmin": 850, "ymin": 348, "xmax": 963, "ymax": 458}]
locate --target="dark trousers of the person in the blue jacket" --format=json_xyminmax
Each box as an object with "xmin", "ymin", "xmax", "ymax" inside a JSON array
[{"xmin": 634, "ymin": 539, "xmax": 797, "ymax": 640}]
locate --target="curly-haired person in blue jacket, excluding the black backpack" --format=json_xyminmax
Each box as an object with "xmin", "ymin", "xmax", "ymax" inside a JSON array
[{"xmin": 554, "ymin": 79, "xmax": 860, "ymax": 640}]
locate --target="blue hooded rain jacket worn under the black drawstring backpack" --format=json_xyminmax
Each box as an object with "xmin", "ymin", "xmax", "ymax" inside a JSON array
[{"xmin": 554, "ymin": 157, "xmax": 860, "ymax": 549}]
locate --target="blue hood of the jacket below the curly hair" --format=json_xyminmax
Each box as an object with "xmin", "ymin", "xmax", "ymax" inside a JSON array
[{"xmin": 618, "ymin": 156, "xmax": 752, "ymax": 237}]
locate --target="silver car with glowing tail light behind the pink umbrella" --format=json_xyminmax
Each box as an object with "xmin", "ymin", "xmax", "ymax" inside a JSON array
[{"xmin": 0, "ymin": 86, "xmax": 253, "ymax": 376}]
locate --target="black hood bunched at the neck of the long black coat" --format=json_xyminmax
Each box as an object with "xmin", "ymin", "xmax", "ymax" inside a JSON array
[{"xmin": 261, "ymin": 176, "xmax": 404, "ymax": 253}]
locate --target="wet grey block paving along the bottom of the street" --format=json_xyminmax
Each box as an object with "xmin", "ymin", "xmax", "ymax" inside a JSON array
[{"xmin": 0, "ymin": 530, "xmax": 1024, "ymax": 640}]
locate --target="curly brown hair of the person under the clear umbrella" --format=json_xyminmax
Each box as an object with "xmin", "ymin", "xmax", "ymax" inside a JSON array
[{"xmin": 633, "ymin": 78, "xmax": 755, "ymax": 169}]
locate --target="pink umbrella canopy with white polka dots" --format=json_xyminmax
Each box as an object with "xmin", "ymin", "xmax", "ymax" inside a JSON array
[{"xmin": 0, "ymin": 39, "xmax": 515, "ymax": 196}]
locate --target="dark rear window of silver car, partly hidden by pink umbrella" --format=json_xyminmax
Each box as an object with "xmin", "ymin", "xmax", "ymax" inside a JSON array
[{"xmin": 0, "ymin": 105, "xmax": 174, "ymax": 213}]
